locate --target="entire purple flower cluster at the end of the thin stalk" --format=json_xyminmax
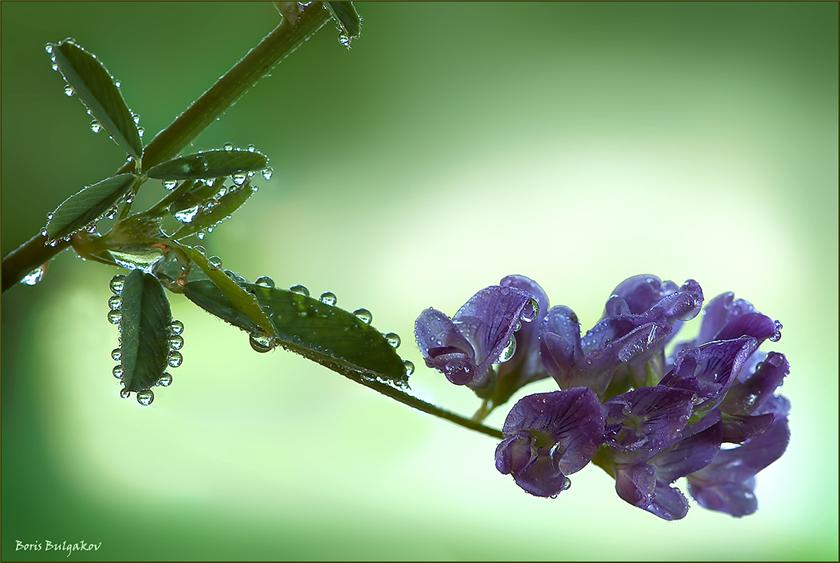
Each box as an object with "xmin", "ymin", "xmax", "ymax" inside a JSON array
[{"xmin": 415, "ymin": 275, "xmax": 790, "ymax": 520}]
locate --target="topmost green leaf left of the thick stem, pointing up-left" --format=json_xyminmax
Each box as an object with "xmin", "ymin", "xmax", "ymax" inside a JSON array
[{"xmin": 51, "ymin": 39, "xmax": 143, "ymax": 159}]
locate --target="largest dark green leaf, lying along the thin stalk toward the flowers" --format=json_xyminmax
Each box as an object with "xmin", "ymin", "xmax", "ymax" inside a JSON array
[{"xmin": 184, "ymin": 281, "xmax": 408, "ymax": 385}]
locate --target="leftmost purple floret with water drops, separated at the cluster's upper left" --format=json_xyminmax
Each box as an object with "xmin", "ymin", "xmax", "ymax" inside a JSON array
[{"xmin": 414, "ymin": 276, "xmax": 548, "ymax": 394}]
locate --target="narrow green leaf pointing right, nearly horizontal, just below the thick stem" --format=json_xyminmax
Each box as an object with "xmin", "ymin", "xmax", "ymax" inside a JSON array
[{"xmin": 146, "ymin": 149, "xmax": 268, "ymax": 180}]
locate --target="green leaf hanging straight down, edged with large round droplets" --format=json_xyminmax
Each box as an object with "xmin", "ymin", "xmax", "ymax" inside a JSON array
[{"xmin": 120, "ymin": 270, "xmax": 172, "ymax": 392}]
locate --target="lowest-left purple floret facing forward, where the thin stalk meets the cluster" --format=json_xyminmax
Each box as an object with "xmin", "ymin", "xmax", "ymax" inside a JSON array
[{"xmin": 496, "ymin": 388, "xmax": 604, "ymax": 497}]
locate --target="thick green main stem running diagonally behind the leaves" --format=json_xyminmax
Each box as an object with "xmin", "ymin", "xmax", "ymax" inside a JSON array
[{"xmin": 2, "ymin": 2, "xmax": 330, "ymax": 291}]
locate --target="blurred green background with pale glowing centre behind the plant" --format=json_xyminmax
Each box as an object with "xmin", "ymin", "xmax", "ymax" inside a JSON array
[{"xmin": 2, "ymin": 2, "xmax": 838, "ymax": 560}]
